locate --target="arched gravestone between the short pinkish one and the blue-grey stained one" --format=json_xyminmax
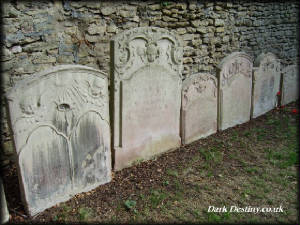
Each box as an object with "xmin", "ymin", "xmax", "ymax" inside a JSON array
[{"xmin": 218, "ymin": 52, "xmax": 253, "ymax": 130}]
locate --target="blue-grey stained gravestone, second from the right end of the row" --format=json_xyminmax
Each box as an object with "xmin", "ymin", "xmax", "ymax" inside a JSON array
[{"xmin": 251, "ymin": 53, "xmax": 280, "ymax": 118}]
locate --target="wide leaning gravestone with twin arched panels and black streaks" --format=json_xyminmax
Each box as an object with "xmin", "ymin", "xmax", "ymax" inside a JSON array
[{"xmin": 7, "ymin": 65, "xmax": 111, "ymax": 215}]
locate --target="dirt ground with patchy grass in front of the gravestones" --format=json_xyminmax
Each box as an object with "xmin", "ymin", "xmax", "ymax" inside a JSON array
[{"xmin": 3, "ymin": 102, "xmax": 299, "ymax": 224}]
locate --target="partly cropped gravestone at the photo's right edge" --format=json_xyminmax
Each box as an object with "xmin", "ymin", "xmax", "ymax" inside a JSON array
[{"xmin": 281, "ymin": 65, "xmax": 299, "ymax": 105}]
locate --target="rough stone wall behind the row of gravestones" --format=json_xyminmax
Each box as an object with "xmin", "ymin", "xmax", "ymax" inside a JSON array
[{"xmin": 1, "ymin": 0, "xmax": 299, "ymax": 163}]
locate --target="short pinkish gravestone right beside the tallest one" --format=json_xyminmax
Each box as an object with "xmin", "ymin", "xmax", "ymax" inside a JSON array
[{"xmin": 181, "ymin": 73, "xmax": 218, "ymax": 144}]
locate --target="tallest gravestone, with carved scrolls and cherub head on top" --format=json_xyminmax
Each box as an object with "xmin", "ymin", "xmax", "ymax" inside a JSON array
[{"xmin": 111, "ymin": 27, "xmax": 183, "ymax": 170}]
